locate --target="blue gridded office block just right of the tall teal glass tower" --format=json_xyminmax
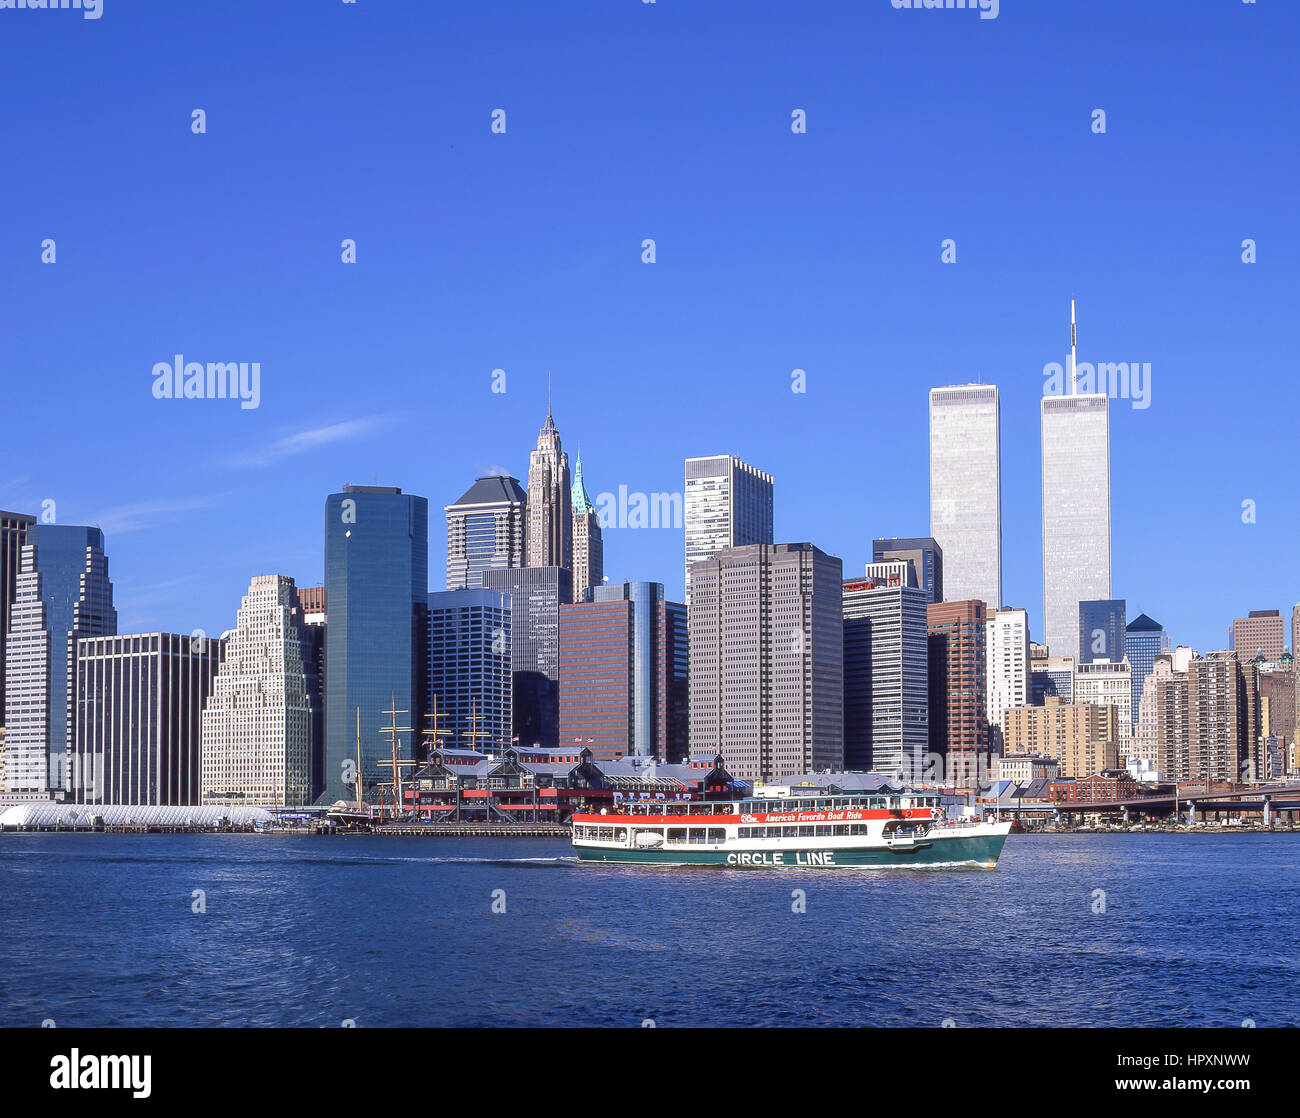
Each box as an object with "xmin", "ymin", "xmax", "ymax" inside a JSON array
[{"xmin": 423, "ymin": 585, "xmax": 517, "ymax": 753}]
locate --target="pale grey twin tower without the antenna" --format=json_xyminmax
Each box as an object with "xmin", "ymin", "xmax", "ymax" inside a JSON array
[{"xmin": 930, "ymin": 385, "xmax": 1002, "ymax": 610}]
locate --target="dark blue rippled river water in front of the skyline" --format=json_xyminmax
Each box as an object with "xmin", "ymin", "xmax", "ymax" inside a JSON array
[{"xmin": 0, "ymin": 835, "xmax": 1300, "ymax": 1027}]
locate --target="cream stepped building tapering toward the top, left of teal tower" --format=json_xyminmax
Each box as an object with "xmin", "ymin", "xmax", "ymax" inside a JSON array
[{"xmin": 200, "ymin": 575, "xmax": 321, "ymax": 807}]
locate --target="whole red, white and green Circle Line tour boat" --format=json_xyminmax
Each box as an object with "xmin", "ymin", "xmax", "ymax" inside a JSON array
[{"xmin": 573, "ymin": 789, "xmax": 1011, "ymax": 870}]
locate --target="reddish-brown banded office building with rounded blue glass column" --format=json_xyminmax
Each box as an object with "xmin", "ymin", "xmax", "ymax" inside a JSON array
[{"xmin": 560, "ymin": 582, "xmax": 689, "ymax": 762}]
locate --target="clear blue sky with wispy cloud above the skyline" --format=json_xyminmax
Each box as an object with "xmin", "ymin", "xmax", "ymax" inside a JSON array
[{"xmin": 0, "ymin": 0, "xmax": 1300, "ymax": 649}]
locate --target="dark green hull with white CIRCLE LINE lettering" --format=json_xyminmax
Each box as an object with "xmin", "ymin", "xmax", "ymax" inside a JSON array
[{"xmin": 575, "ymin": 827, "xmax": 1006, "ymax": 870}]
